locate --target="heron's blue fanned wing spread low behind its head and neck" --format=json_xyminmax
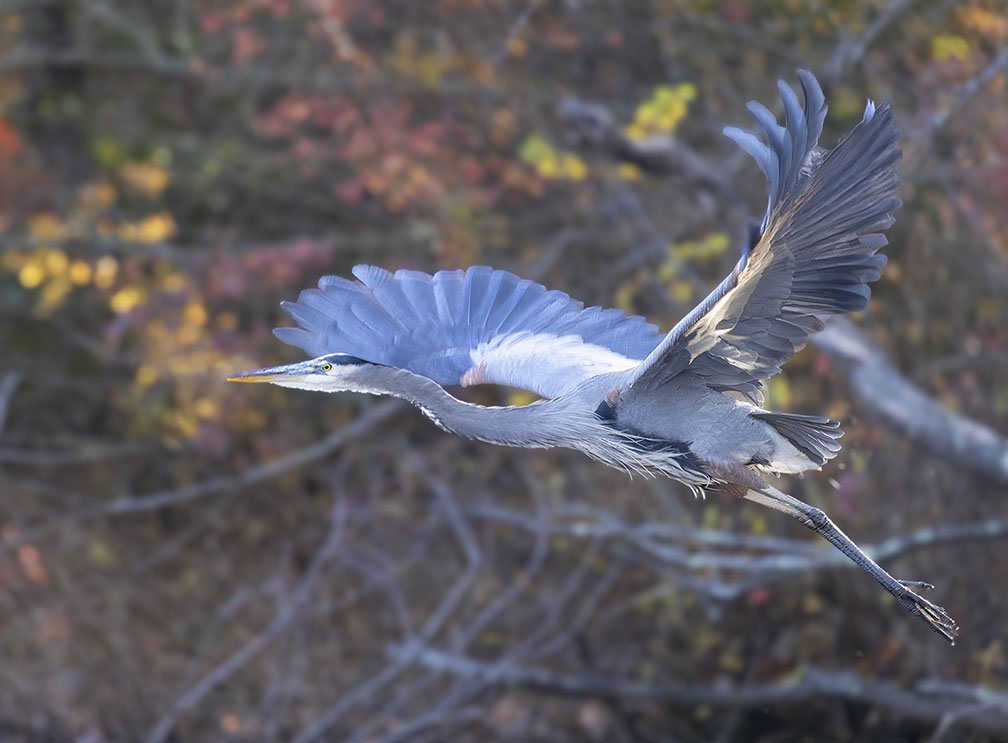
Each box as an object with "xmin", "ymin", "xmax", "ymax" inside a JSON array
[{"xmin": 274, "ymin": 265, "xmax": 660, "ymax": 397}]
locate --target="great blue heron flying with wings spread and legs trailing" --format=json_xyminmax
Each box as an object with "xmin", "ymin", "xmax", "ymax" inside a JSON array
[{"xmin": 232, "ymin": 71, "xmax": 957, "ymax": 642}]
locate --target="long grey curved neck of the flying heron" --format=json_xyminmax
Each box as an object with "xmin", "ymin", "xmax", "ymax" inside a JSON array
[{"xmin": 355, "ymin": 367, "xmax": 594, "ymax": 449}]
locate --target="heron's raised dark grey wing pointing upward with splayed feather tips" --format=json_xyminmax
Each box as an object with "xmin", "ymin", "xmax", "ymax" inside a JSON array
[{"xmin": 627, "ymin": 71, "xmax": 900, "ymax": 403}]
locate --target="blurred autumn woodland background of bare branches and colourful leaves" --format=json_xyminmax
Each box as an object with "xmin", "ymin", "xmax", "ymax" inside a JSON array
[{"xmin": 0, "ymin": 0, "xmax": 1008, "ymax": 743}]
